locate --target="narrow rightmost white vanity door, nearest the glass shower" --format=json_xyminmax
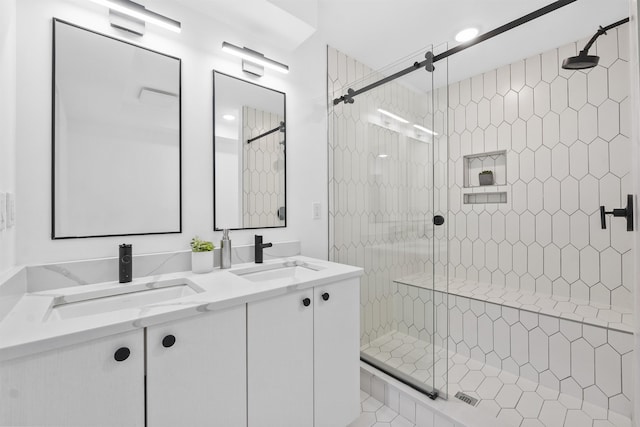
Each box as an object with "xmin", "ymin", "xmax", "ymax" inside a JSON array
[{"xmin": 314, "ymin": 279, "xmax": 360, "ymax": 427}]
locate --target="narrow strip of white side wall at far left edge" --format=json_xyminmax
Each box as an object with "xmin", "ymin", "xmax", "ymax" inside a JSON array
[{"xmin": 0, "ymin": 0, "xmax": 16, "ymax": 273}]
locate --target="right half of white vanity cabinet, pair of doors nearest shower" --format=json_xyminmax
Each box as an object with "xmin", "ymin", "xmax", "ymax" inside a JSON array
[{"xmin": 247, "ymin": 279, "xmax": 360, "ymax": 427}]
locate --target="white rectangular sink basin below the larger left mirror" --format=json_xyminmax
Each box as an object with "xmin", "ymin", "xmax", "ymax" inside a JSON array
[{"xmin": 45, "ymin": 280, "xmax": 204, "ymax": 321}]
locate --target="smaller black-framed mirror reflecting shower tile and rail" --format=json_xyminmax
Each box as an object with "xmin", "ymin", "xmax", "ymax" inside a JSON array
[{"xmin": 213, "ymin": 71, "xmax": 287, "ymax": 230}]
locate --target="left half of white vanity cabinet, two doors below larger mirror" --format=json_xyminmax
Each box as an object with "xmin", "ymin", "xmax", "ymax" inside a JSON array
[{"xmin": 0, "ymin": 304, "xmax": 247, "ymax": 427}]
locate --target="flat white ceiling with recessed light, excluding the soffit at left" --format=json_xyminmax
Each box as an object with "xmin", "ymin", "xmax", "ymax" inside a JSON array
[{"xmin": 319, "ymin": 0, "xmax": 629, "ymax": 87}]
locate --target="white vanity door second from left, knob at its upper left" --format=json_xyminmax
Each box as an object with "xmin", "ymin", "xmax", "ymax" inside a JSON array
[{"xmin": 147, "ymin": 304, "xmax": 247, "ymax": 427}]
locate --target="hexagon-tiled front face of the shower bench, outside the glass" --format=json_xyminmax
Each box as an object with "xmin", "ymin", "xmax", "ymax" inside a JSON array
[{"xmin": 436, "ymin": 292, "xmax": 633, "ymax": 417}]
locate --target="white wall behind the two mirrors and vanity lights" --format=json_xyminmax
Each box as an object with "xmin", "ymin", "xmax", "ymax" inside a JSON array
[{"xmin": 16, "ymin": 0, "xmax": 327, "ymax": 264}]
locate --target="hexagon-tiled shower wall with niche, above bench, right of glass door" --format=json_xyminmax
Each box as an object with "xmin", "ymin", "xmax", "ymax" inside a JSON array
[{"xmin": 444, "ymin": 24, "xmax": 633, "ymax": 307}]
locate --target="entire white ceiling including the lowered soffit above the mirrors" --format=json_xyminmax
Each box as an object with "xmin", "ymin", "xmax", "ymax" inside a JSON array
[{"xmin": 176, "ymin": 0, "xmax": 629, "ymax": 87}]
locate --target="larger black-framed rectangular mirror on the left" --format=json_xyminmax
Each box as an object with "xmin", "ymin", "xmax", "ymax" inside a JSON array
[{"xmin": 52, "ymin": 19, "xmax": 182, "ymax": 239}]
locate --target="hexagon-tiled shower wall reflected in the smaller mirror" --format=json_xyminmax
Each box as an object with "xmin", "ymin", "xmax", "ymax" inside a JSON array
[{"xmin": 242, "ymin": 106, "xmax": 284, "ymax": 228}]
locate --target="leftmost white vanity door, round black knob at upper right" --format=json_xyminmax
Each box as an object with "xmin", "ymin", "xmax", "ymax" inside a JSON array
[{"xmin": 0, "ymin": 329, "xmax": 144, "ymax": 427}]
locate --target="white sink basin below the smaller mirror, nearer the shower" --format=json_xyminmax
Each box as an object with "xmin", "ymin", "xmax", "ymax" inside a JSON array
[{"xmin": 231, "ymin": 261, "xmax": 324, "ymax": 283}]
